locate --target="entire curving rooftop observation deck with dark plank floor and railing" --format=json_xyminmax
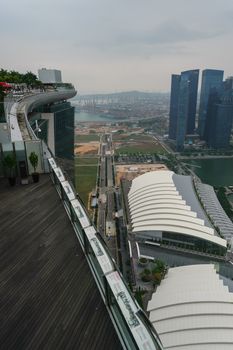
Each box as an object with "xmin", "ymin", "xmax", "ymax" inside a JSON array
[{"xmin": 0, "ymin": 86, "xmax": 162, "ymax": 350}]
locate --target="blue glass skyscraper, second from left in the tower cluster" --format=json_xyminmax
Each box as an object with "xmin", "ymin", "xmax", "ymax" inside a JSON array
[{"xmin": 181, "ymin": 69, "xmax": 199, "ymax": 134}]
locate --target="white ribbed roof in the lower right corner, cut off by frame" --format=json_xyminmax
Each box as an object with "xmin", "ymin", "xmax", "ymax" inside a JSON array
[{"xmin": 147, "ymin": 264, "xmax": 233, "ymax": 350}]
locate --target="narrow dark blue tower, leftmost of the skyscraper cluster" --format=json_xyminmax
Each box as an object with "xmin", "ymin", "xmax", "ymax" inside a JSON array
[{"xmin": 169, "ymin": 74, "xmax": 180, "ymax": 140}]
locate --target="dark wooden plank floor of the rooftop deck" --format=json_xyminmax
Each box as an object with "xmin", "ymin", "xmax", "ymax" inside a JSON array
[{"xmin": 0, "ymin": 175, "xmax": 121, "ymax": 350}]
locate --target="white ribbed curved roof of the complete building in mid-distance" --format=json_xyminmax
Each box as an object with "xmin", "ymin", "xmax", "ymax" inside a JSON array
[{"xmin": 128, "ymin": 171, "xmax": 226, "ymax": 247}]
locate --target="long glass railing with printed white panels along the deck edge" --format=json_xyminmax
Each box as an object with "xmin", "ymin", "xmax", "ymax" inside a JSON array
[{"xmin": 48, "ymin": 157, "xmax": 163, "ymax": 350}]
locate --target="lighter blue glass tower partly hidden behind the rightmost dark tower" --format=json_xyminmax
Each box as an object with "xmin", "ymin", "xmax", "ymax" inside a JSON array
[{"xmin": 198, "ymin": 69, "xmax": 224, "ymax": 139}]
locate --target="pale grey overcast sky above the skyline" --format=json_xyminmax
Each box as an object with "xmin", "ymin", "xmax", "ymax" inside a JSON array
[{"xmin": 0, "ymin": 0, "xmax": 233, "ymax": 94}]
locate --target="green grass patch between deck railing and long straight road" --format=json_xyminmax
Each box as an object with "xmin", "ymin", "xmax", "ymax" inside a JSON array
[{"xmin": 75, "ymin": 157, "xmax": 98, "ymax": 207}]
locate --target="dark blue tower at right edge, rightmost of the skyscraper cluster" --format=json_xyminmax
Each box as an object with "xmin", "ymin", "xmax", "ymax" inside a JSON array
[{"xmin": 204, "ymin": 88, "xmax": 233, "ymax": 149}]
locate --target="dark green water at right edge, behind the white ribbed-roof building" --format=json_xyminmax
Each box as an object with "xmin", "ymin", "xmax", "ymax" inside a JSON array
[{"xmin": 183, "ymin": 158, "xmax": 233, "ymax": 186}]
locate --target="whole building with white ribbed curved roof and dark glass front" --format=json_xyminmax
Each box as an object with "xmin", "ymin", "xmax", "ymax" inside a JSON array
[{"xmin": 128, "ymin": 171, "xmax": 227, "ymax": 256}]
